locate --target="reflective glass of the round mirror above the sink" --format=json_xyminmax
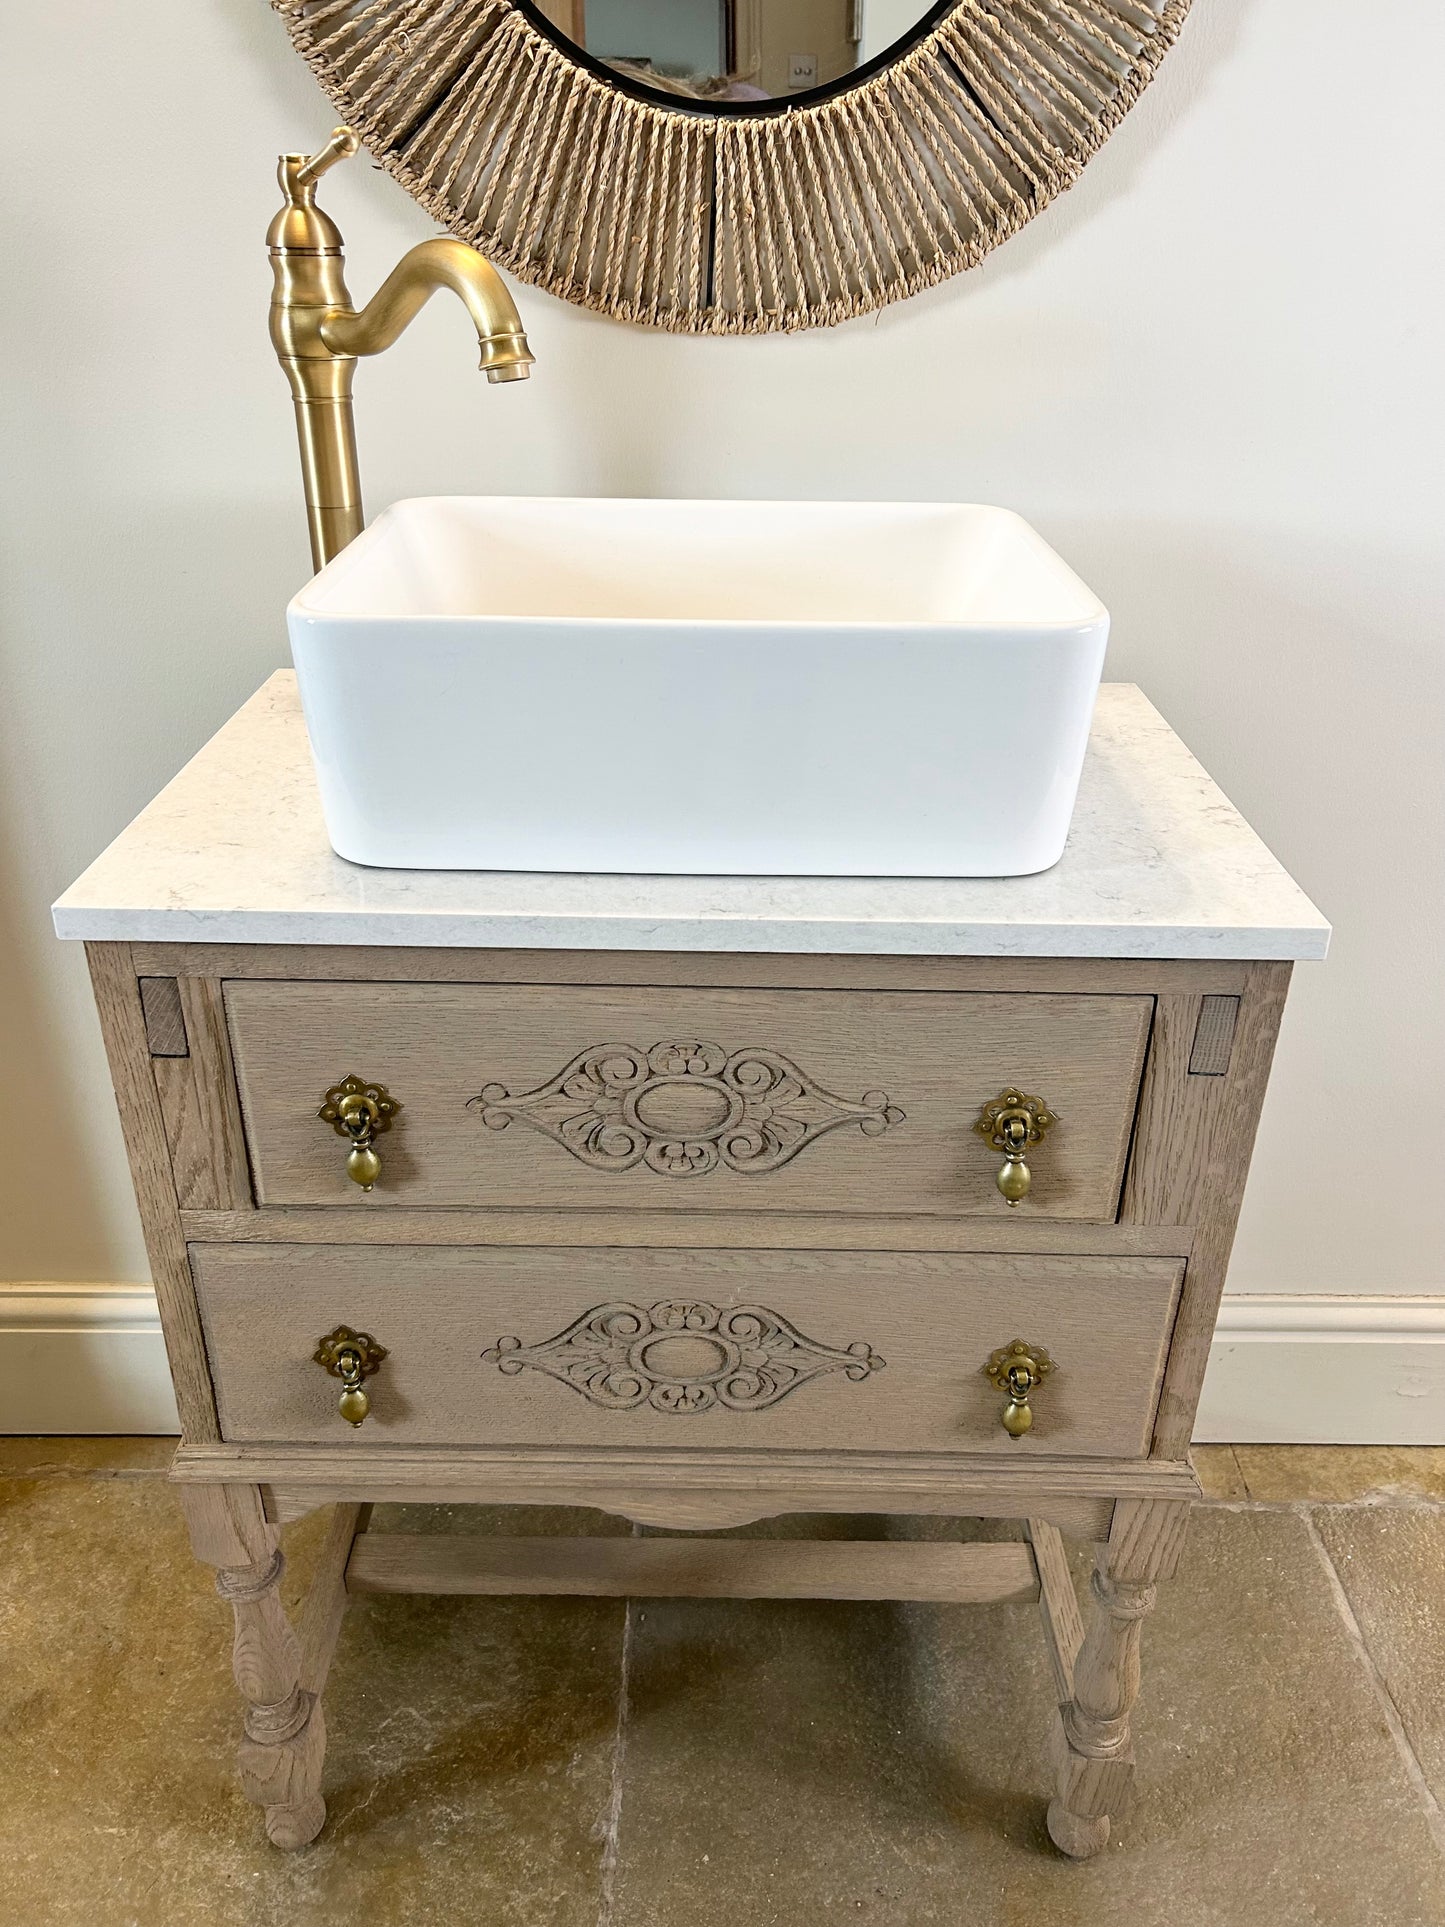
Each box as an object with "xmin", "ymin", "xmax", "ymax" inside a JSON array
[{"xmin": 532, "ymin": 0, "xmax": 950, "ymax": 112}]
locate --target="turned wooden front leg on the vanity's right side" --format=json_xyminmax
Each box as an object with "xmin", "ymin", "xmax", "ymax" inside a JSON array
[{"xmin": 1035, "ymin": 1499, "xmax": 1189, "ymax": 1860}]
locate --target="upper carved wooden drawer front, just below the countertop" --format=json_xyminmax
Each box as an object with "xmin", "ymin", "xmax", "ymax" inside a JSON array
[{"xmin": 225, "ymin": 981, "xmax": 1152, "ymax": 1220}]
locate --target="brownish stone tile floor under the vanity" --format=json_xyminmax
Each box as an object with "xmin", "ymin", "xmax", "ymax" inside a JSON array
[{"xmin": 0, "ymin": 1439, "xmax": 1445, "ymax": 1927}]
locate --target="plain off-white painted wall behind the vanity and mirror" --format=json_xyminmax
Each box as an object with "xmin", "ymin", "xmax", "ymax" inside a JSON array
[{"xmin": 0, "ymin": 0, "xmax": 1445, "ymax": 1348}]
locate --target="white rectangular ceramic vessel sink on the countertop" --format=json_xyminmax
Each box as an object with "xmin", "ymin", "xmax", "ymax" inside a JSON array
[{"xmin": 287, "ymin": 497, "xmax": 1108, "ymax": 877}]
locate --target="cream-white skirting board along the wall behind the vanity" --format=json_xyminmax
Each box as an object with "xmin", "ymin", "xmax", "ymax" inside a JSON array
[{"xmin": 0, "ymin": 1285, "xmax": 1445, "ymax": 1445}]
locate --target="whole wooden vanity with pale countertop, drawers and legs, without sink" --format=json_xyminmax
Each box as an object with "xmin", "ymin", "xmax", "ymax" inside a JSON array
[{"xmin": 56, "ymin": 674, "xmax": 1327, "ymax": 1856}]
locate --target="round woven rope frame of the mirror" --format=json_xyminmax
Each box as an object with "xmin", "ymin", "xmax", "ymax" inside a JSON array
[{"xmin": 272, "ymin": 0, "xmax": 1191, "ymax": 335}]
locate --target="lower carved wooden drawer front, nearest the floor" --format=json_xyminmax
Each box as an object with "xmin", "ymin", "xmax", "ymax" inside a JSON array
[{"xmin": 191, "ymin": 1245, "xmax": 1183, "ymax": 1463}]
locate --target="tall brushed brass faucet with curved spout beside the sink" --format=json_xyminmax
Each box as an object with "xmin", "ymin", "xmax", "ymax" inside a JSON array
[{"xmin": 266, "ymin": 127, "xmax": 534, "ymax": 568}]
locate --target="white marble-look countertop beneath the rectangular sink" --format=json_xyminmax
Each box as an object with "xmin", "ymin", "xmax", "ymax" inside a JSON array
[{"xmin": 54, "ymin": 671, "xmax": 1329, "ymax": 958}]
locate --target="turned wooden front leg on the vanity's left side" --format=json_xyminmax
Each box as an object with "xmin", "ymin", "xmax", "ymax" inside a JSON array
[{"xmin": 181, "ymin": 1486, "xmax": 326, "ymax": 1848}]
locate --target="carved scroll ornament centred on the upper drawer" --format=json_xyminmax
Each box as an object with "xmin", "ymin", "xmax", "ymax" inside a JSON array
[{"xmin": 466, "ymin": 1039, "xmax": 904, "ymax": 1177}]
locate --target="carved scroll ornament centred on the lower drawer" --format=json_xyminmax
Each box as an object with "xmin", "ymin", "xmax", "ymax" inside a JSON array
[{"xmin": 482, "ymin": 1299, "xmax": 884, "ymax": 1412}]
